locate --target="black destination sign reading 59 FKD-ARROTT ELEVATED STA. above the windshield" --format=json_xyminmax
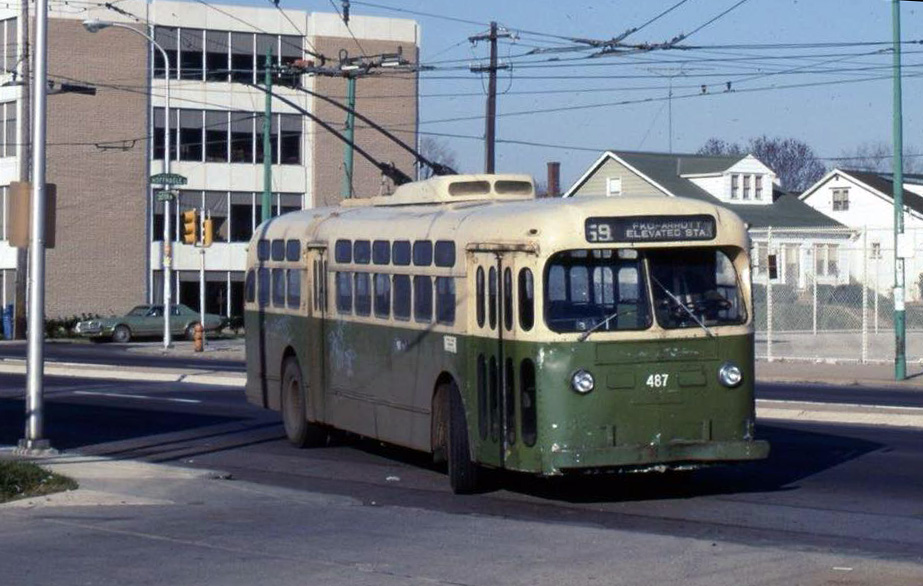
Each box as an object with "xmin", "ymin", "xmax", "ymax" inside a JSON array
[{"xmin": 585, "ymin": 215, "xmax": 715, "ymax": 243}]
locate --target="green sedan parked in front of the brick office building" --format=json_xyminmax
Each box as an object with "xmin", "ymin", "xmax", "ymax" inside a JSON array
[{"xmin": 74, "ymin": 304, "xmax": 227, "ymax": 344}]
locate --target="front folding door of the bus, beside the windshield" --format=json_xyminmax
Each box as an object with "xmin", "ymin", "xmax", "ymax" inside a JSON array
[{"xmin": 466, "ymin": 246, "xmax": 516, "ymax": 468}]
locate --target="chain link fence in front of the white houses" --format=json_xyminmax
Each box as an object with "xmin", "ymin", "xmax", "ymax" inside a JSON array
[{"xmin": 750, "ymin": 227, "xmax": 923, "ymax": 363}]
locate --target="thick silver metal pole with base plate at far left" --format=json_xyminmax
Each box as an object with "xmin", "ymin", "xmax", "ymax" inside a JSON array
[{"xmin": 19, "ymin": 0, "xmax": 51, "ymax": 453}]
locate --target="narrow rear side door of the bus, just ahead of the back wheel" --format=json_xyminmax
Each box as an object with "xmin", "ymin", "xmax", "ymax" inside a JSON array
[{"xmin": 302, "ymin": 242, "xmax": 327, "ymax": 422}]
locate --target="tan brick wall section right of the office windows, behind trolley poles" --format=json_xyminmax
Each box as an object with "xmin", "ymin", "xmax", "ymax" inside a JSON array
[{"xmin": 309, "ymin": 37, "xmax": 417, "ymax": 207}]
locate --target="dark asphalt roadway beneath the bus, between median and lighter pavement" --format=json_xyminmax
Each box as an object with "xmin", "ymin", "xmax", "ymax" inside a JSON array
[{"xmin": 0, "ymin": 375, "xmax": 923, "ymax": 564}]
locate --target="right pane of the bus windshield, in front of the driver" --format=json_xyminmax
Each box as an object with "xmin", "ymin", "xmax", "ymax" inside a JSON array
[{"xmin": 646, "ymin": 248, "xmax": 747, "ymax": 329}]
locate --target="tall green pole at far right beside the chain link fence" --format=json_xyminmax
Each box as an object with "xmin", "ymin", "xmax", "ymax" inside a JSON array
[{"xmin": 891, "ymin": 0, "xmax": 907, "ymax": 381}]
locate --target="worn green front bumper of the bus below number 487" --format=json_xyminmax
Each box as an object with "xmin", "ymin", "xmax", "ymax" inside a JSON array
[{"xmin": 545, "ymin": 441, "xmax": 769, "ymax": 474}]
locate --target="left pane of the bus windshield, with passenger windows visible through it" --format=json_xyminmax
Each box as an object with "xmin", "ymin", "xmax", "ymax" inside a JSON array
[{"xmin": 545, "ymin": 249, "xmax": 651, "ymax": 332}]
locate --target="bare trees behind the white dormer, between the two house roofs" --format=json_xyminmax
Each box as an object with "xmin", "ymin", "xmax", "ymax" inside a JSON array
[{"xmin": 698, "ymin": 135, "xmax": 827, "ymax": 191}]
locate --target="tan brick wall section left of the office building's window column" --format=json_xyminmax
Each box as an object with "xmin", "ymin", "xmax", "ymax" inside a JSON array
[{"xmin": 46, "ymin": 19, "xmax": 148, "ymax": 317}]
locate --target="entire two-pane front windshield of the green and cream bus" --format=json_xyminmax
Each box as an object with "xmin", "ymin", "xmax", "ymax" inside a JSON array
[{"xmin": 545, "ymin": 248, "xmax": 747, "ymax": 330}]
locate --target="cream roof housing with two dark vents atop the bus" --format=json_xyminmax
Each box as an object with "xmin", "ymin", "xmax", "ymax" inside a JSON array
[{"xmin": 360, "ymin": 175, "xmax": 535, "ymax": 206}]
